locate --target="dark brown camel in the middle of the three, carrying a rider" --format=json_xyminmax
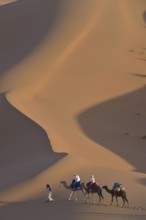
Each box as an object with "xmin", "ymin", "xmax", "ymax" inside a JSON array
[{"xmin": 82, "ymin": 183, "xmax": 104, "ymax": 204}]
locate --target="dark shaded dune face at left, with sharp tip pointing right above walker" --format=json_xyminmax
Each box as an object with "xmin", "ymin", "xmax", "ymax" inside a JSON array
[{"xmin": 0, "ymin": 95, "xmax": 65, "ymax": 190}]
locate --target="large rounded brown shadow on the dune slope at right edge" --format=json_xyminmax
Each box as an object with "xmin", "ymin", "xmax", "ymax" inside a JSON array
[{"xmin": 77, "ymin": 87, "xmax": 146, "ymax": 173}]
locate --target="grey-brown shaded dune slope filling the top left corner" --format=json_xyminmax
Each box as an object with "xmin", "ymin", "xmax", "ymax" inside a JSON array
[{"xmin": 0, "ymin": 0, "xmax": 60, "ymax": 75}]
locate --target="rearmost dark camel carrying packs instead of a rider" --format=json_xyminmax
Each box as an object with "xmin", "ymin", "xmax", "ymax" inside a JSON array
[{"xmin": 102, "ymin": 186, "xmax": 129, "ymax": 207}]
